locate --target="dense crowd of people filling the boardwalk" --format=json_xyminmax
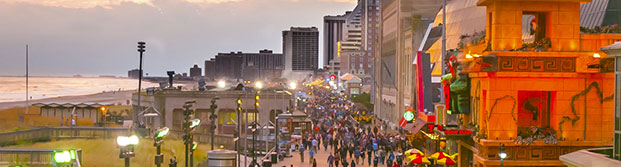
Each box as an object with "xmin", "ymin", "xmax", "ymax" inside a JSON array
[{"xmin": 292, "ymin": 89, "xmax": 413, "ymax": 167}]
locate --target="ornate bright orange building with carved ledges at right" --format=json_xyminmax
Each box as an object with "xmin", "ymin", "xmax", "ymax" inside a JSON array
[{"xmin": 457, "ymin": 0, "xmax": 621, "ymax": 166}]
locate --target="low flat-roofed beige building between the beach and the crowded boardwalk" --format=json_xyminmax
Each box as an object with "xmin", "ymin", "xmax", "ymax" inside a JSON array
[{"xmin": 132, "ymin": 87, "xmax": 292, "ymax": 135}]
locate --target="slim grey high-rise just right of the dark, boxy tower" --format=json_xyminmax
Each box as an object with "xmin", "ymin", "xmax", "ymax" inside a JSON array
[{"xmin": 322, "ymin": 12, "xmax": 351, "ymax": 66}]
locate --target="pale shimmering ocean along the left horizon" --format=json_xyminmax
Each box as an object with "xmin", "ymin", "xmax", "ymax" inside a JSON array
[{"xmin": 0, "ymin": 77, "xmax": 158, "ymax": 102}]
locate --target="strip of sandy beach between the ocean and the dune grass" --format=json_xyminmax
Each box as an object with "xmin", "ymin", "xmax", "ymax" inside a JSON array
[{"xmin": 0, "ymin": 90, "xmax": 135, "ymax": 110}]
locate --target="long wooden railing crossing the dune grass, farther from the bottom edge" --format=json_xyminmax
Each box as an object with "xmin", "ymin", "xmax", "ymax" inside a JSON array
[{"xmin": 0, "ymin": 127, "xmax": 129, "ymax": 146}]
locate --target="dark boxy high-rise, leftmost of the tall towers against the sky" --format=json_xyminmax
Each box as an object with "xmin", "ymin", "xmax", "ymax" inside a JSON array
[{"xmin": 282, "ymin": 27, "xmax": 319, "ymax": 72}]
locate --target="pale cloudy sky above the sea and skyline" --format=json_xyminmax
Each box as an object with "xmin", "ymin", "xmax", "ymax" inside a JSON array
[{"xmin": 0, "ymin": 0, "xmax": 357, "ymax": 76}]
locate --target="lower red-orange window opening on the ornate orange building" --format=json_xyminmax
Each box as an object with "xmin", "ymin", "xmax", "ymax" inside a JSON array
[{"xmin": 517, "ymin": 91, "xmax": 553, "ymax": 134}]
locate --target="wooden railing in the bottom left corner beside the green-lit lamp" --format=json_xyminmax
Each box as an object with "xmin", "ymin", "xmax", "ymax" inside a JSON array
[{"xmin": 0, "ymin": 148, "xmax": 82, "ymax": 167}]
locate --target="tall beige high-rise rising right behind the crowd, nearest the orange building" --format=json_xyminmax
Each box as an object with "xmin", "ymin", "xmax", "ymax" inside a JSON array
[{"xmin": 364, "ymin": 0, "xmax": 444, "ymax": 124}]
